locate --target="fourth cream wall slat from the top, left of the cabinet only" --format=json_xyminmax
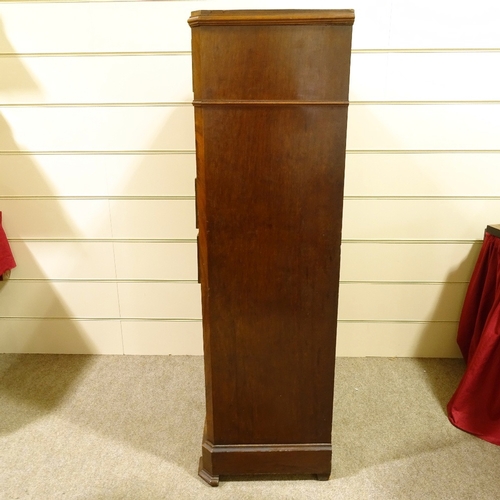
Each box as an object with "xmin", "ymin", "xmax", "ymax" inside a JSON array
[{"xmin": 0, "ymin": 154, "xmax": 196, "ymax": 197}]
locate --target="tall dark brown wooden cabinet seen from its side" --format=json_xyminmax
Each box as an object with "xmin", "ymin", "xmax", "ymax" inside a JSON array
[{"xmin": 189, "ymin": 10, "xmax": 354, "ymax": 485}]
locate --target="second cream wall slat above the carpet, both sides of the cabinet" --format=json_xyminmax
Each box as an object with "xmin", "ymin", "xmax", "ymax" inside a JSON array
[{"xmin": 0, "ymin": 280, "xmax": 467, "ymax": 321}]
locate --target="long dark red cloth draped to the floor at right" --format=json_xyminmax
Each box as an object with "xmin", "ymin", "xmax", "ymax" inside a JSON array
[{"xmin": 447, "ymin": 233, "xmax": 500, "ymax": 445}]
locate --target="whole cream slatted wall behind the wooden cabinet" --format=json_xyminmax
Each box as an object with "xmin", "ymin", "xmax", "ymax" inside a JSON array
[{"xmin": 0, "ymin": 0, "xmax": 500, "ymax": 356}]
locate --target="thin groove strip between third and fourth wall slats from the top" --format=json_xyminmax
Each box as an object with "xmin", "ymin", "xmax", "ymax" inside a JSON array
[{"xmin": 0, "ymin": 149, "xmax": 500, "ymax": 156}]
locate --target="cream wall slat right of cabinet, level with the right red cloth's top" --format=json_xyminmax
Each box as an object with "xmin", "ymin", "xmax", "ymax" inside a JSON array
[{"xmin": 342, "ymin": 199, "xmax": 500, "ymax": 240}]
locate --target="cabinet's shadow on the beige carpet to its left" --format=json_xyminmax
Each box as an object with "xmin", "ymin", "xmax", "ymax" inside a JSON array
[{"xmin": 50, "ymin": 356, "xmax": 205, "ymax": 477}]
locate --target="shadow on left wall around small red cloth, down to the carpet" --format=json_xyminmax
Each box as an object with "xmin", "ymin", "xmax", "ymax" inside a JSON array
[{"xmin": 0, "ymin": 115, "xmax": 99, "ymax": 353}]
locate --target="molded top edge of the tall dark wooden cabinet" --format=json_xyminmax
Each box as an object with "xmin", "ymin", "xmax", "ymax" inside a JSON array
[{"xmin": 188, "ymin": 9, "xmax": 354, "ymax": 28}]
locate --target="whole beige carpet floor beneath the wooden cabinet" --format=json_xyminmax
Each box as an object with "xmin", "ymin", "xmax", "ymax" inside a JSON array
[{"xmin": 0, "ymin": 354, "xmax": 500, "ymax": 500}]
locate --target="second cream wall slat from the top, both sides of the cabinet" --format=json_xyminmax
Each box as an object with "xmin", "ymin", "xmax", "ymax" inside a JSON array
[{"xmin": 0, "ymin": 51, "xmax": 500, "ymax": 105}]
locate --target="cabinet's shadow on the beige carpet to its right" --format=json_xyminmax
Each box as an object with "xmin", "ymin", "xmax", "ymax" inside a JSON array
[{"xmin": 332, "ymin": 358, "xmax": 468, "ymax": 479}]
